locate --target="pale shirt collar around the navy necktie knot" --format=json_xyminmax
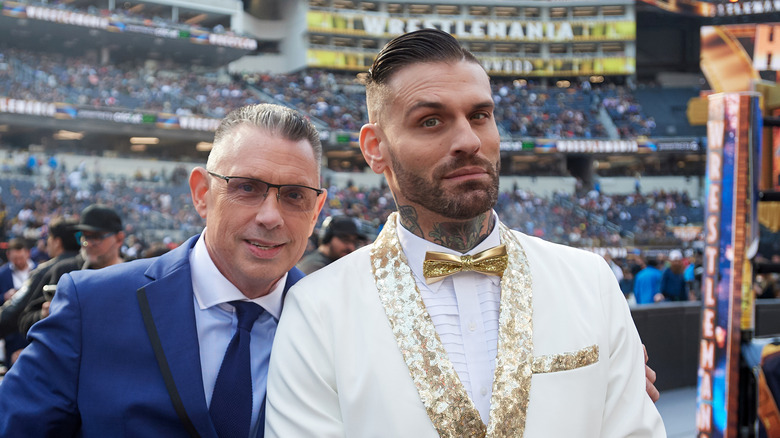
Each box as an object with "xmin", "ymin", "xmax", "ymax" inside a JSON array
[{"xmin": 190, "ymin": 229, "xmax": 287, "ymax": 321}]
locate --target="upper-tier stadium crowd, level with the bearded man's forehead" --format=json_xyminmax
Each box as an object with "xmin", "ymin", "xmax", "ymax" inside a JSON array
[{"xmin": 0, "ymin": 48, "xmax": 655, "ymax": 139}]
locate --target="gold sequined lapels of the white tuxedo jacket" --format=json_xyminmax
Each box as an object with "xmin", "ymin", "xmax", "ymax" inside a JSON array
[{"xmin": 371, "ymin": 213, "xmax": 533, "ymax": 438}]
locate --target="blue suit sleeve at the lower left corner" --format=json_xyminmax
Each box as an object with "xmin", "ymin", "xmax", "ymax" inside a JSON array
[{"xmin": 0, "ymin": 275, "xmax": 82, "ymax": 437}]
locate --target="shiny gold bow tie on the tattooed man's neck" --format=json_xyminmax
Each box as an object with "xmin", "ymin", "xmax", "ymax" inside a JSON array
[{"xmin": 423, "ymin": 245, "xmax": 508, "ymax": 284}]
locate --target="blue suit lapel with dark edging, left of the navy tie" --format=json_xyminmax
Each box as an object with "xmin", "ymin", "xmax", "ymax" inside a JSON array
[{"xmin": 138, "ymin": 236, "xmax": 216, "ymax": 437}]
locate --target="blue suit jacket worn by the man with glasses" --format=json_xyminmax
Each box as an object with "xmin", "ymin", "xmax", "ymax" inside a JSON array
[{"xmin": 0, "ymin": 236, "xmax": 303, "ymax": 438}]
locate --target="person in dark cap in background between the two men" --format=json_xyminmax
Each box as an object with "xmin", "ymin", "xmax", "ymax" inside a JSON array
[{"xmin": 295, "ymin": 216, "xmax": 365, "ymax": 274}]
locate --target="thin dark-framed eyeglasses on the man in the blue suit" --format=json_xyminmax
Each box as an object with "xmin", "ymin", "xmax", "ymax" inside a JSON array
[{"xmin": 208, "ymin": 170, "xmax": 324, "ymax": 212}]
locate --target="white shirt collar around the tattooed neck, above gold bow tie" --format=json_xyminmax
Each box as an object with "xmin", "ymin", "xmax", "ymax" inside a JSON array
[{"xmin": 396, "ymin": 211, "xmax": 501, "ymax": 293}]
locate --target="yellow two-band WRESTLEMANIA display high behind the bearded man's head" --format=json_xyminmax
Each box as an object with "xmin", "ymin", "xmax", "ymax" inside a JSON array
[{"xmin": 306, "ymin": 10, "xmax": 636, "ymax": 77}]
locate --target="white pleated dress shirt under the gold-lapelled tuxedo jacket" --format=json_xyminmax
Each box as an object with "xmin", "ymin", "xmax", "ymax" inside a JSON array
[{"xmin": 398, "ymin": 212, "xmax": 501, "ymax": 424}]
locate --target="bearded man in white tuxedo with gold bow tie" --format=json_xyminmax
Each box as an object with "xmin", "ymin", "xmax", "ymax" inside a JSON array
[{"xmin": 266, "ymin": 29, "xmax": 665, "ymax": 438}]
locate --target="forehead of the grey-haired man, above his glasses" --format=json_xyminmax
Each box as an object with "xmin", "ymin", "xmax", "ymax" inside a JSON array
[{"xmin": 215, "ymin": 124, "xmax": 319, "ymax": 185}]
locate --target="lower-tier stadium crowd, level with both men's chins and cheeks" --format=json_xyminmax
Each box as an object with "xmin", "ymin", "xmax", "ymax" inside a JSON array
[{"xmin": 0, "ymin": 151, "xmax": 703, "ymax": 258}]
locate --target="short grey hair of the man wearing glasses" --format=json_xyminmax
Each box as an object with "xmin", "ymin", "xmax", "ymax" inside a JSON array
[{"xmin": 206, "ymin": 103, "xmax": 322, "ymax": 172}]
